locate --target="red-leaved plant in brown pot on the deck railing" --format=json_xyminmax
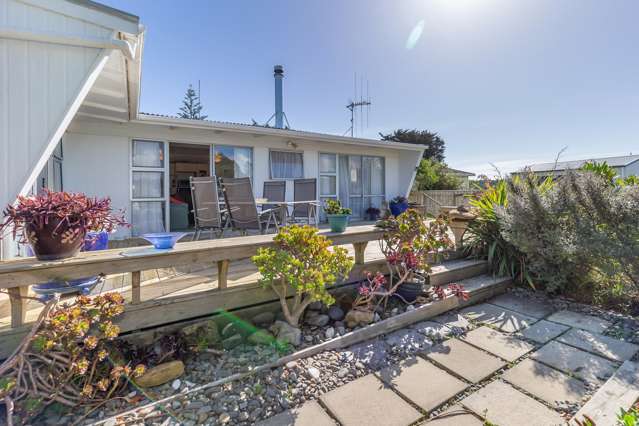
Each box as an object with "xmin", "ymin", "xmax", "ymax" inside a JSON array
[{"xmin": 0, "ymin": 190, "xmax": 127, "ymax": 260}]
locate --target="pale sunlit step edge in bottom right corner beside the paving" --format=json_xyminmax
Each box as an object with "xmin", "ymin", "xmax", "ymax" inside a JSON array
[{"xmin": 570, "ymin": 361, "xmax": 639, "ymax": 425}]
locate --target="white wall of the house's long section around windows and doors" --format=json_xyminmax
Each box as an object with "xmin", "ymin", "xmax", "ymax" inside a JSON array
[{"xmin": 63, "ymin": 119, "xmax": 421, "ymax": 238}]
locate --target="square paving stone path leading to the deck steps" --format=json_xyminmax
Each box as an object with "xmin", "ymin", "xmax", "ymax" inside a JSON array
[{"xmin": 260, "ymin": 293, "xmax": 639, "ymax": 426}]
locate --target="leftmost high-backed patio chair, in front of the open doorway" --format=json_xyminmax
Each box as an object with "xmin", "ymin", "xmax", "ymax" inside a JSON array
[{"xmin": 189, "ymin": 176, "xmax": 228, "ymax": 241}]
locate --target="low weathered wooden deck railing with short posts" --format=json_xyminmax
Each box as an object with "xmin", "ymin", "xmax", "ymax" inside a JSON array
[{"xmin": 0, "ymin": 225, "xmax": 382, "ymax": 328}]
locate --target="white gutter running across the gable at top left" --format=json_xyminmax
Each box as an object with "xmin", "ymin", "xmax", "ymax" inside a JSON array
[{"xmin": 0, "ymin": 27, "xmax": 137, "ymax": 60}]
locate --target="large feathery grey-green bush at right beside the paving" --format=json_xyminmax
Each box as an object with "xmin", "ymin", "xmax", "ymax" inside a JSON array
[{"xmin": 497, "ymin": 170, "xmax": 639, "ymax": 307}]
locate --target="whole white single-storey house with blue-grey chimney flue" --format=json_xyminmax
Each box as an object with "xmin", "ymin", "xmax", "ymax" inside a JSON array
[{"xmin": 0, "ymin": 0, "xmax": 423, "ymax": 258}]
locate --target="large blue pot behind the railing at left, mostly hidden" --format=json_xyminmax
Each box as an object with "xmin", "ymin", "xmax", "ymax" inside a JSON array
[{"xmin": 27, "ymin": 231, "xmax": 109, "ymax": 302}]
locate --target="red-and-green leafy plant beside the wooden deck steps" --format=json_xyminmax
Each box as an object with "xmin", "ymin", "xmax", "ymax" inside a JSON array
[{"xmin": 354, "ymin": 209, "xmax": 452, "ymax": 309}]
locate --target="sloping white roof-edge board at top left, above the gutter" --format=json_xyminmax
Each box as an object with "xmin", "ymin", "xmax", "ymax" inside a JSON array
[{"xmin": 18, "ymin": 0, "xmax": 140, "ymax": 34}]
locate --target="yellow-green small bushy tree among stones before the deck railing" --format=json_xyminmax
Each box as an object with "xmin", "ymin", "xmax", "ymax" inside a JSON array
[{"xmin": 253, "ymin": 225, "xmax": 353, "ymax": 327}]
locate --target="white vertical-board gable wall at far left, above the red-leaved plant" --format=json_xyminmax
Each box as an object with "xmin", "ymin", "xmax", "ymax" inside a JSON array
[{"xmin": 0, "ymin": 0, "xmax": 112, "ymax": 257}]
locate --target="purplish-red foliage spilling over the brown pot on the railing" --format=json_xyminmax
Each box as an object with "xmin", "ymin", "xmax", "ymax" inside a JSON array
[{"xmin": 0, "ymin": 190, "xmax": 128, "ymax": 243}]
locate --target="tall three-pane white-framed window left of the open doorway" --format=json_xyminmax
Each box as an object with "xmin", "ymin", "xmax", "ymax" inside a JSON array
[{"xmin": 131, "ymin": 140, "xmax": 166, "ymax": 236}]
